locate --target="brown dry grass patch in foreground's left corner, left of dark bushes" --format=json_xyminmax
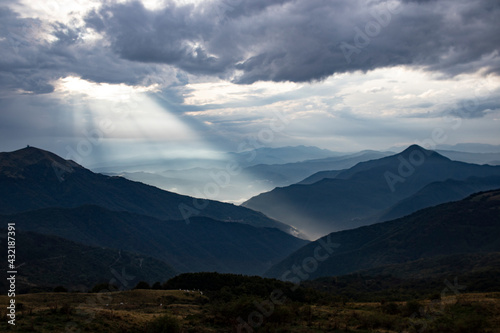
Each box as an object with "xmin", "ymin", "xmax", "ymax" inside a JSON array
[{"xmin": 0, "ymin": 290, "xmax": 204, "ymax": 333}]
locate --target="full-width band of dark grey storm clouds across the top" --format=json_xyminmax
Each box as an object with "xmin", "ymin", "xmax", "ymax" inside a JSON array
[{"xmin": 0, "ymin": 0, "xmax": 500, "ymax": 93}]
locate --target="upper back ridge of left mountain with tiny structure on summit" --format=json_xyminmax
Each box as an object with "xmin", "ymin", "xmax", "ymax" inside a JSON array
[{"xmin": 0, "ymin": 147, "xmax": 294, "ymax": 233}]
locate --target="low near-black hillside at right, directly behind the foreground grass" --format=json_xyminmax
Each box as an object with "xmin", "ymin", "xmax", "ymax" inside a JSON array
[{"xmin": 301, "ymin": 252, "xmax": 500, "ymax": 300}]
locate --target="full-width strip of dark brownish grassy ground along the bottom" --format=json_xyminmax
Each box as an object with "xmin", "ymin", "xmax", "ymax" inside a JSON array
[{"xmin": 0, "ymin": 290, "xmax": 500, "ymax": 333}]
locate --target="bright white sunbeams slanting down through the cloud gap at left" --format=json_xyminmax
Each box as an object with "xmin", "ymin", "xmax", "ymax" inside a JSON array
[{"xmin": 54, "ymin": 77, "xmax": 216, "ymax": 167}]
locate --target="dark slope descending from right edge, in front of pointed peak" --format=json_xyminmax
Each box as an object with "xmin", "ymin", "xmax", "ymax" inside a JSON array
[{"xmin": 266, "ymin": 190, "xmax": 500, "ymax": 279}]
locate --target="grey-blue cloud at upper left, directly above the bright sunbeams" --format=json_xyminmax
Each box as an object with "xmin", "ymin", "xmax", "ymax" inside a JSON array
[{"xmin": 0, "ymin": 7, "xmax": 176, "ymax": 94}]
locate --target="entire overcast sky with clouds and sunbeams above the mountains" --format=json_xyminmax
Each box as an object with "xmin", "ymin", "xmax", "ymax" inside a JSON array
[{"xmin": 0, "ymin": 0, "xmax": 500, "ymax": 165}]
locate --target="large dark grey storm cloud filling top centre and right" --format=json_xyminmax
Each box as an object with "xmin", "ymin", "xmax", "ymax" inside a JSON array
[{"xmin": 83, "ymin": 0, "xmax": 500, "ymax": 83}]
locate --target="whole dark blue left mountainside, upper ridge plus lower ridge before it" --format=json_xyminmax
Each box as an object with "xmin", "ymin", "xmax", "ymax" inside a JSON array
[{"xmin": 0, "ymin": 147, "xmax": 307, "ymax": 274}]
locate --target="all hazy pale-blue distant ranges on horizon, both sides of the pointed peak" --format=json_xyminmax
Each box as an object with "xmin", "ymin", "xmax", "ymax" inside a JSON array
[{"xmin": 93, "ymin": 144, "xmax": 500, "ymax": 204}]
